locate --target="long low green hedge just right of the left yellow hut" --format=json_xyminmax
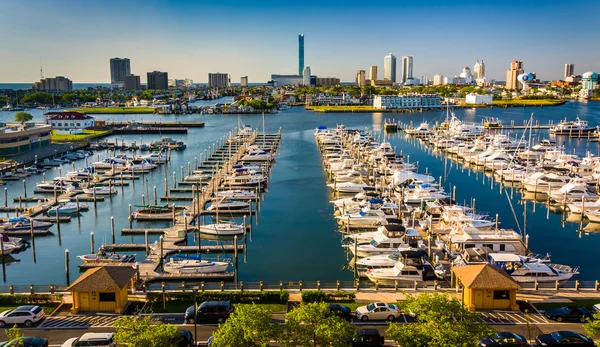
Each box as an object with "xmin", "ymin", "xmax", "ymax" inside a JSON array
[{"xmin": 147, "ymin": 290, "xmax": 290, "ymax": 304}]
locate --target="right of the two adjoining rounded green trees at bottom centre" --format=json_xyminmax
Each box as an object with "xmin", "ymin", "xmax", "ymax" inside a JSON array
[{"xmin": 278, "ymin": 303, "xmax": 355, "ymax": 347}]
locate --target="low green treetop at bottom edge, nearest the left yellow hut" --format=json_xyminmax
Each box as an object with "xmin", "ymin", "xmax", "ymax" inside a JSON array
[{"xmin": 114, "ymin": 316, "xmax": 181, "ymax": 347}]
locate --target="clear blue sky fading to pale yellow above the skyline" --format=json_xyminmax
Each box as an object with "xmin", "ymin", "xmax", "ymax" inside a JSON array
[{"xmin": 0, "ymin": 0, "xmax": 600, "ymax": 83}]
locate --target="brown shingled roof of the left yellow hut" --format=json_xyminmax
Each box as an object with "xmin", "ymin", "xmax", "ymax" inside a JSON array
[{"xmin": 67, "ymin": 266, "xmax": 137, "ymax": 292}]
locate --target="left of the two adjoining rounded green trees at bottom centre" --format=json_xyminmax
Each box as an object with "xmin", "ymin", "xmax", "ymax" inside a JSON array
[{"xmin": 212, "ymin": 304, "xmax": 279, "ymax": 347}]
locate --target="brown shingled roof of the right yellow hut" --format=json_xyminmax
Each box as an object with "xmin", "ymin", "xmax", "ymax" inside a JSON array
[{"xmin": 452, "ymin": 264, "xmax": 521, "ymax": 290}]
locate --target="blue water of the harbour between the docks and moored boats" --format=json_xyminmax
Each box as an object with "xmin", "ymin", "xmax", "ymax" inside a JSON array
[{"xmin": 0, "ymin": 102, "xmax": 600, "ymax": 284}]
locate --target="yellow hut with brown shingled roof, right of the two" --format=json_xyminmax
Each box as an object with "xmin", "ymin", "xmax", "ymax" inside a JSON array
[{"xmin": 452, "ymin": 264, "xmax": 521, "ymax": 311}]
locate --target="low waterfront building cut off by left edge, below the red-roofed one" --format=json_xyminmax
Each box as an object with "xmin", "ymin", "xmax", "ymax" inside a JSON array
[{"xmin": 0, "ymin": 123, "xmax": 52, "ymax": 156}]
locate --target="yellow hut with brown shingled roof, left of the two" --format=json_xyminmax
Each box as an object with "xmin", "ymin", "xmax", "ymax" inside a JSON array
[{"xmin": 67, "ymin": 266, "xmax": 137, "ymax": 313}]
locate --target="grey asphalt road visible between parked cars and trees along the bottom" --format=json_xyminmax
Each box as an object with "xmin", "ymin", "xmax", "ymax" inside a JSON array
[{"xmin": 1, "ymin": 315, "xmax": 585, "ymax": 347}]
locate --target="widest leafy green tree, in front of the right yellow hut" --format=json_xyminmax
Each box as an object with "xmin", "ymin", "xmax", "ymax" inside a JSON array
[{"xmin": 387, "ymin": 293, "xmax": 494, "ymax": 347}]
